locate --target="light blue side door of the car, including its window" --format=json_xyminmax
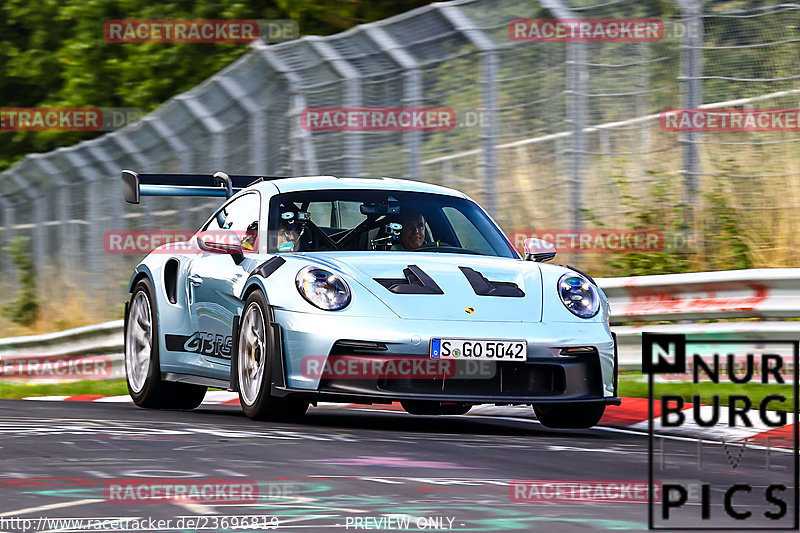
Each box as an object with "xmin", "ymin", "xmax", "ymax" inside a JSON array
[{"xmin": 187, "ymin": 191, "xmax": 261, "ymax": 368}]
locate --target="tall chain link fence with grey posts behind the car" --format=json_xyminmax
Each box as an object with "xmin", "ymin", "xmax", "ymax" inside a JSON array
[{"xmin": 0, "ymin": 0, "xmax": 800, "ymax": 310}]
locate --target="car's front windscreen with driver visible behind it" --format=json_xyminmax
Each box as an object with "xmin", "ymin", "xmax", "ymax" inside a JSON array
[{"xmin": 268, "ymin": 190, "xmax": 518, "ymax": 258}]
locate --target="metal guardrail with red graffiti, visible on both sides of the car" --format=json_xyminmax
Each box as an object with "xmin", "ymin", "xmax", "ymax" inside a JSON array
[{"xmin": 0, "ymin": 268, "xmax": 800, "ymax": 376}]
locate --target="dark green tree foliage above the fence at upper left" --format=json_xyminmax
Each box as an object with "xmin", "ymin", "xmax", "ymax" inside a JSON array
[{"xmin": 0, "ymin": 0, "xmax": 426, "ymax": 169}]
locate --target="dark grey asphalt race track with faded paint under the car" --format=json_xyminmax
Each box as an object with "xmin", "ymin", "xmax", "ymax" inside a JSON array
[{"xmin": 0, "ymin": 400, "xmax": 791, "ymax": 533}]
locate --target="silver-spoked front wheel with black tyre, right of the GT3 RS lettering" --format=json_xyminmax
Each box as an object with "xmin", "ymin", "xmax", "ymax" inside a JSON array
[{"xmin": 236, "ymin": 291, "xmax": 308, "ymax": 421}]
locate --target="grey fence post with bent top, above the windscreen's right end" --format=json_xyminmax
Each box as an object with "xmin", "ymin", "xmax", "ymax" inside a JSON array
[{"xmin": 434, "ymin": 4, "xmax": 498, "ymax": 216}]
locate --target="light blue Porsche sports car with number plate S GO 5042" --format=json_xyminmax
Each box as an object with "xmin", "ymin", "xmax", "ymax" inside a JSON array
[{"xmin": 122, "ymin": 170, "xmax": 620, "ymax": 428}]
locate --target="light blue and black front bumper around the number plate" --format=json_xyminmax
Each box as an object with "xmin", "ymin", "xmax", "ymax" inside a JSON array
[{"xmin": 274, "ymin": 309, "xmax": 619, "ymax": 404}]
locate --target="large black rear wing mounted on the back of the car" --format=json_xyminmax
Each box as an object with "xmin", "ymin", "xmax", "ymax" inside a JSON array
[{"xmin": 117, "ymin": 170, "xmax": 281, "ymax": 204}]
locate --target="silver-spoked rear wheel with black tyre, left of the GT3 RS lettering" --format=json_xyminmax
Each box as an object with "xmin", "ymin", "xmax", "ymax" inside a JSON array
[{"xmin": 125, "ymin": 278, "xmax": 206, "ymax": 409}]
